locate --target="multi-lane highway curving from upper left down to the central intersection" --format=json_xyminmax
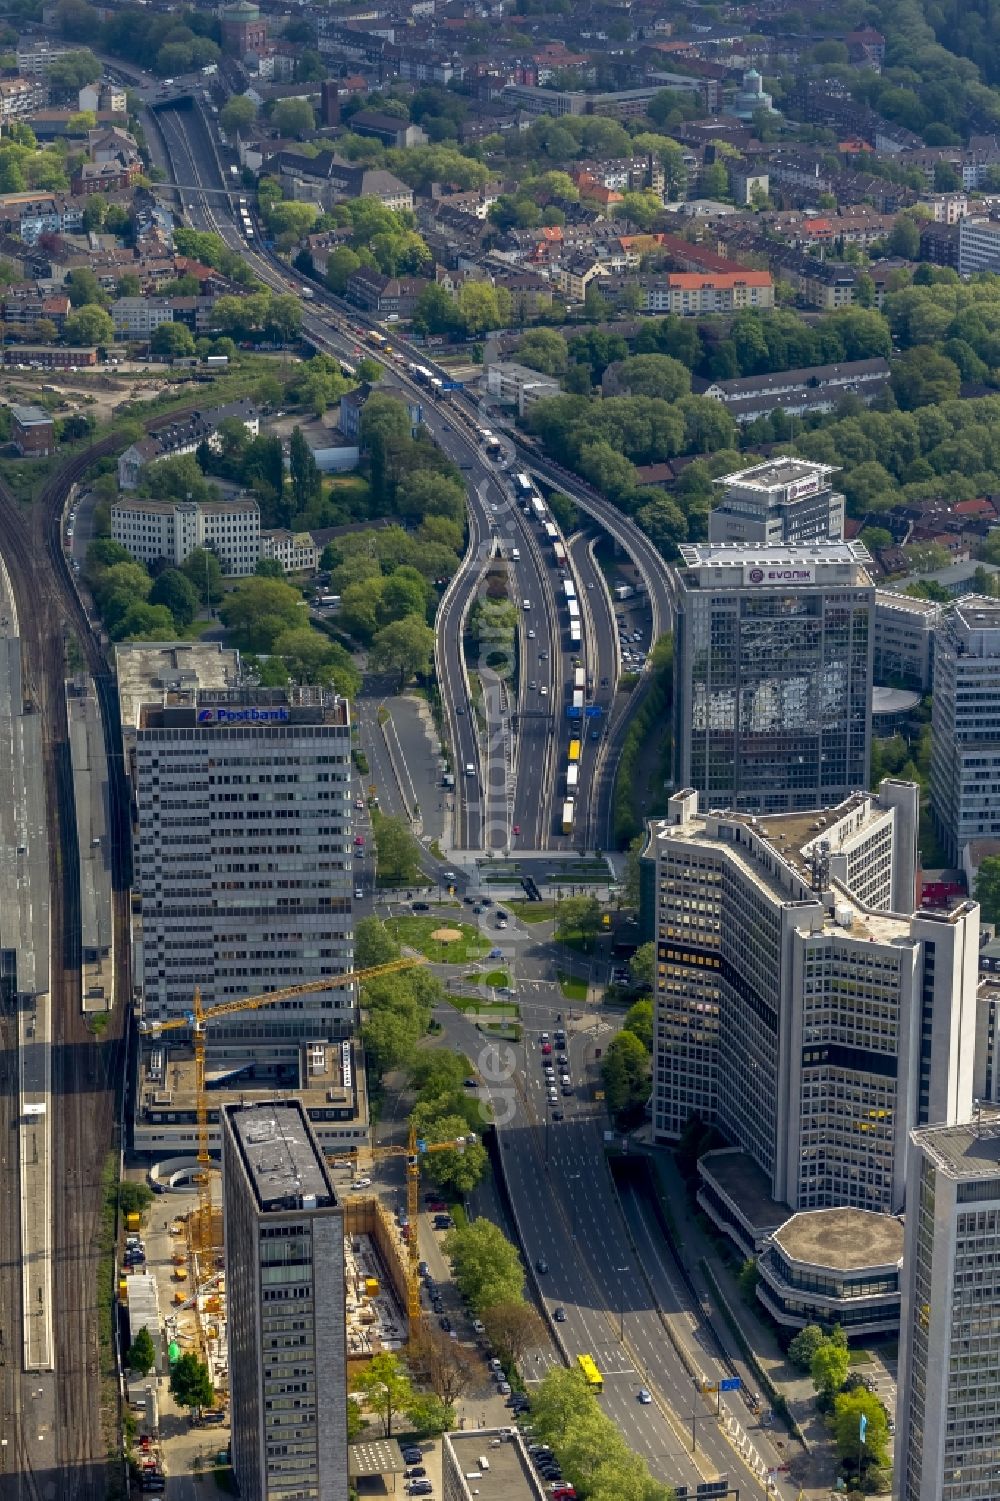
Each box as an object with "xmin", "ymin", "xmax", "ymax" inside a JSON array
[{"xmin": 155, "ymin": 96, "xmax": 651, "ymax": 853}]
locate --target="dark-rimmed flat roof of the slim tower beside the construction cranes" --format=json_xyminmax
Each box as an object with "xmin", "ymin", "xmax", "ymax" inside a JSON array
[{"xmin": 224, "ymin": 1100, "xmax": 336, "ymax": 1214}]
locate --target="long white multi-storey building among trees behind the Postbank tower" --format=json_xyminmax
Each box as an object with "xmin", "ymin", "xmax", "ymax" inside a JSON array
[{"xmin": 111, "ymin": 495, "xmax": 261, "ymax": 578}]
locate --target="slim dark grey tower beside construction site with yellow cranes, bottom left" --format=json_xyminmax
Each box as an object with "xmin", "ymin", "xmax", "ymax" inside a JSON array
[{"xmin": 222, "ymin": 1100, "xmax": 348, "ymax": 1501}]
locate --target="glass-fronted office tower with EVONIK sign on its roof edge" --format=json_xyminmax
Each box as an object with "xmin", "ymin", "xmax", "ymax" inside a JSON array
[{"xmin": 670, "ymin": 542, "xmax": 875, "ymax": 814}]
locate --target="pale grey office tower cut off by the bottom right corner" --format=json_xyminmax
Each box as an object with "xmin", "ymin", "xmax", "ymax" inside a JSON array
[{"xmin": 893, "ymin": 1109, "xmax": 1000, "ymax": 1501}]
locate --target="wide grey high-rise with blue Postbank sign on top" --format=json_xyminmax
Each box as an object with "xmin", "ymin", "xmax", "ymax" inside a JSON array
[{"xmin": 117, "ymin": 663, "xmax": 356, "ymax": 1050}]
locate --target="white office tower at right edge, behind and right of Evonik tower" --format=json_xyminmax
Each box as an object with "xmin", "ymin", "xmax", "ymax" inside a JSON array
[{"xmin": 931, "ymin": 594, "xmax": 1000, "ymax": 865}]
